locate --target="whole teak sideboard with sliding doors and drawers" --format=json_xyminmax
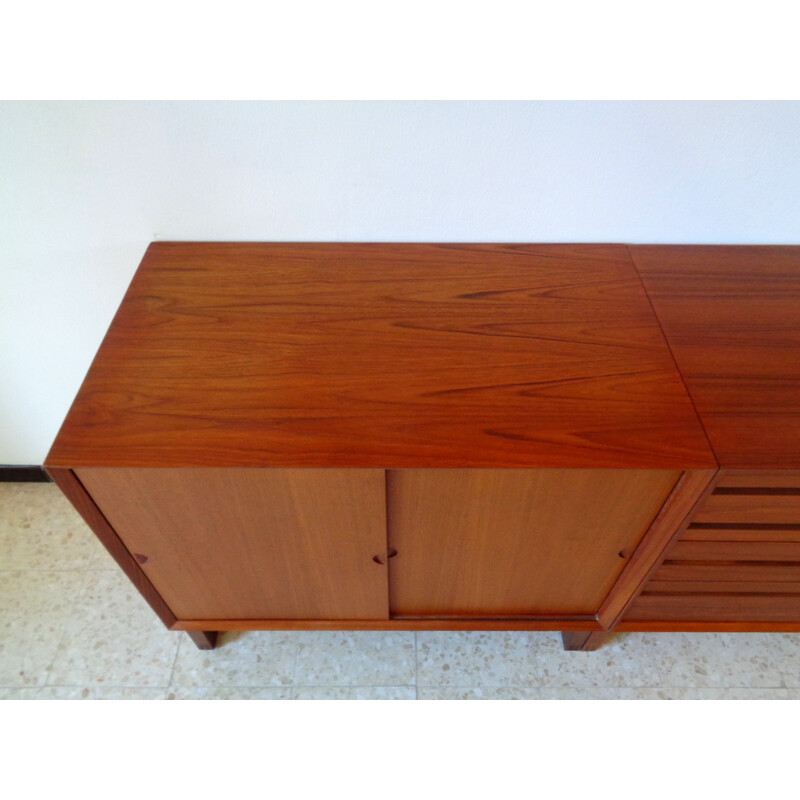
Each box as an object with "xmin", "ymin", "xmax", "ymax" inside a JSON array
[{"xmin": 45, "ymin": 242, "xmax": 800, "ymax": 649}]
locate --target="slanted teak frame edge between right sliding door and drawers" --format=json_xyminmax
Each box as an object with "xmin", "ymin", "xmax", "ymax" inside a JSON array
[{"xmin": 597, "ymin": 470, "xmax": 716, "ymax": 628}]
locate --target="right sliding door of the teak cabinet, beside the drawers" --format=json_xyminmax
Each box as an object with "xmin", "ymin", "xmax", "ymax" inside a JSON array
[{"xmin": 387, "ymin": 469, "xmax": 681, "ymax": 617}]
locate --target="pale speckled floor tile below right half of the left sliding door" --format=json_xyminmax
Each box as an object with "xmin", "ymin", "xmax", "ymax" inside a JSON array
[{"xmin": 295, "ymin": 631, "xmax": 416, "ymax": 686}]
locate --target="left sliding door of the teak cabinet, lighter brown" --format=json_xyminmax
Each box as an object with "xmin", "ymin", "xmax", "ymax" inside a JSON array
[{"xmin": 77, "ymin": 468, "xmax": 388, "ymax": 619}]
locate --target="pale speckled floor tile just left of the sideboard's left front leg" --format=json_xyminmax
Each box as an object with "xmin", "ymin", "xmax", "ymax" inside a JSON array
[{"xmin": 48, "ymin": 571, "xmax": 179, "ymax": 686}]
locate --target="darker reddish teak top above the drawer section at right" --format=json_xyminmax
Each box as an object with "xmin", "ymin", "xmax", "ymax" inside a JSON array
[{"xmin": 629, "ymin": 245, "xmax": 800, "ymax": 470}]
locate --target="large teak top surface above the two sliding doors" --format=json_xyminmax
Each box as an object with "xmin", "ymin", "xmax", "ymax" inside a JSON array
[{"xmin": 46, "ymin": 242, "xmax": 716, "ymax": 468}]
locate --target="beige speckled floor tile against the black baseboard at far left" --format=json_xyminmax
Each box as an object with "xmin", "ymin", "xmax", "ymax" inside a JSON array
[{"xmin": 0, "ymin": 483, "xmax": 116, "ymax": 570}]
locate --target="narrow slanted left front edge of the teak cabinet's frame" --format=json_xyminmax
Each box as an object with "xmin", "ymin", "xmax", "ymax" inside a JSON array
[{"xmin": 47, "ymin": 467, "xmax": 176, "ymax": 628}]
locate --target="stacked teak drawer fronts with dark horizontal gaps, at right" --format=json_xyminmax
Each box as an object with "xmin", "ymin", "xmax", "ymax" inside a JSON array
[{"xmin": 625, "ymin": 470, "xmax": 800, "ymax": 622}]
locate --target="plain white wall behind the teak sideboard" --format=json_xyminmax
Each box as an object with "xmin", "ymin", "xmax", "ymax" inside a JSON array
[{"xmin": 0, "ymin": 102, "xmax": 800, "ymax": 464}]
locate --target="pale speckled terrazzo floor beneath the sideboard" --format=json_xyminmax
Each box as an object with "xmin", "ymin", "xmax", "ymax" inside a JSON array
[{"xmin": 0, "ymin": 483, "xmax": 800, "ymax": 700}]
